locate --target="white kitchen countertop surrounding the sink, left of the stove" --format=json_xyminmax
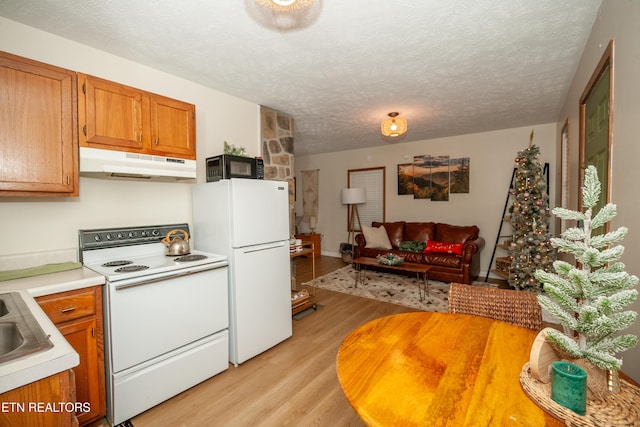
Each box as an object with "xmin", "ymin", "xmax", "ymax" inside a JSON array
[{"xmin": 0, "ymin": 267, "xmax": 104, "ymax": 393}]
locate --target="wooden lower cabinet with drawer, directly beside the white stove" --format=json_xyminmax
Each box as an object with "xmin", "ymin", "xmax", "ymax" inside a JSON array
[{"xmin": 36, "ymin": 286, "xmax": 106, "ymax": 425}]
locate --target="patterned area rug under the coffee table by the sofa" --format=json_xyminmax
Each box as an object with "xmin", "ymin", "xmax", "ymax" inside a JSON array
[{"xmin": 303, "ymin": 265, "xmax": 462, "ymax": 312}]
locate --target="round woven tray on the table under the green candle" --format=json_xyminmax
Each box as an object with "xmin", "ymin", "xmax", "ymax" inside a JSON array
[{"xmin": 520, "ymin": 363, "xmax": 640, "ymax": 427}]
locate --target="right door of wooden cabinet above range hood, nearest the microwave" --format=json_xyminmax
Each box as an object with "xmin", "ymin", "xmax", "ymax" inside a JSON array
[{"xmin": 150, "ymin": 95, "xmax": 196, "ymax": 160}]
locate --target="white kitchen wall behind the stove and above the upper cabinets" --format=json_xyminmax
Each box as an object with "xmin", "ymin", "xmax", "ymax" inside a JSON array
[{"xmin": 0, "ymin": 17, "xmax": 261, "ymax": 256}]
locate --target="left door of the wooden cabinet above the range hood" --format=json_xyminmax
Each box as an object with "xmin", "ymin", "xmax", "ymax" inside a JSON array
[{"xmin": 78, "ymin": 74, "xmax": 149, "ymax": 152}]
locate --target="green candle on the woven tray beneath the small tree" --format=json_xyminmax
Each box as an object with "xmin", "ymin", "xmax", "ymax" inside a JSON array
[{"xmin": 551, "ymin": 362, "xmax": 587, "ymax": 415}]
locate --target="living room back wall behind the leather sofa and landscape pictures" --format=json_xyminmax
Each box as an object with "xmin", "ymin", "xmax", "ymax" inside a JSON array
[{"xmin": 296, "ymin": 123, "xmax": 557, "ymax": 279}]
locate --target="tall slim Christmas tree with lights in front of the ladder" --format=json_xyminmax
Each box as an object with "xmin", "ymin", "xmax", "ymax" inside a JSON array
[{"xmin": 509, "ymin": 132, "xmax": 554, "ymax": 291}]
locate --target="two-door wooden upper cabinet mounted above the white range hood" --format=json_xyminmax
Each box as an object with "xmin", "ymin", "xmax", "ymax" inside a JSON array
[{"xmin": 78, "ymin": 73, "xmax": 196, "ymax": 160}]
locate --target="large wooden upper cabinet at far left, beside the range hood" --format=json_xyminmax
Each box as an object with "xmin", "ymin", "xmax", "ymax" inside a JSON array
[{"xmin": 0, "ymin": 52, "xmax": 78, "ymax": 196}]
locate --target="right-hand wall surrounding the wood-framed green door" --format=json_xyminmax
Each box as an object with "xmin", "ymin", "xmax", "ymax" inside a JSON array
[{"xmin": 558, "ymin": 0, "xmax": 640, "ymax": 380}]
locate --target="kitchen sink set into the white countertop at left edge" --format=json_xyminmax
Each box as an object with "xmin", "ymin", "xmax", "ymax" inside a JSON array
[{"xmin": 0, "ymin": 292, "xmax": 53, "ymax": 363}]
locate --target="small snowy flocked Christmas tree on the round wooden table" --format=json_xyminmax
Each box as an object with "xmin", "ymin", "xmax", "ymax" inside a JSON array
[{"xmin": 535, "ymin": 166, "xmax": 638, "ymax": 370}]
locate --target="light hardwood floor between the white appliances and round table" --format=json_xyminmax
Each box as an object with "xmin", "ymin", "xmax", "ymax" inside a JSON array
[{"xmin": 125, "ymin": 257, "xmax": 422, "ymax": 427}]
